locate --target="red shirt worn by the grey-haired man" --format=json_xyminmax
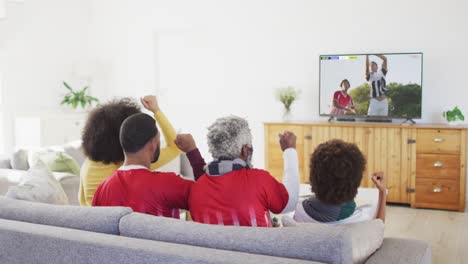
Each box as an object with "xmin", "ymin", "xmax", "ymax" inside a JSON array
[{"xmin": 189, "ymin": 168, "xmax": 289, "ymax": 226}]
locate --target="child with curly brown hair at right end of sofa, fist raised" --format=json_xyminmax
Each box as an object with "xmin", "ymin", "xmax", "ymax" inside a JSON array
[{"xmin": 294, "ymin": 139, "xmax": 387, "ymax": 223}]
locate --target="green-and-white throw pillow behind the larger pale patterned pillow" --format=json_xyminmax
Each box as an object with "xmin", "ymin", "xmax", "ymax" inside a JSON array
[{"xmin": 28, "ymin": 150, "xmax": 80, "ymax": 175}]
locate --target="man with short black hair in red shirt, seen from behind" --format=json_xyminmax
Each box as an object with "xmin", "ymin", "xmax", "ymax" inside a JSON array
[{"xmin": 92, "ymin": 113, "xmax": 193, "ymax": 218}]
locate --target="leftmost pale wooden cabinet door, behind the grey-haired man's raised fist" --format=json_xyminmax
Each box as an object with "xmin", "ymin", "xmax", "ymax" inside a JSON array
[{"xmin": 265, "ymin": 124, "xmax": 304, "ymax": 182}]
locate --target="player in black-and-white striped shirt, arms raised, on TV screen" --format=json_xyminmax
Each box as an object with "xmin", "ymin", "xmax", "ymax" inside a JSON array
[{"xmin": 366, "ymin": 55, "xmax": 388, "ymax": 116}]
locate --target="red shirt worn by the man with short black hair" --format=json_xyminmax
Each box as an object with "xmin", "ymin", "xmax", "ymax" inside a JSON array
[{"xmin": 93, "ymin": 169, "xmax": 193, "ymax": 218}]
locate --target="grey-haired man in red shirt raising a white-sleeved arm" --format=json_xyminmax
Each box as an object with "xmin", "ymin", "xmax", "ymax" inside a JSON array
[{"xmin": 184, "ymin": 116, "xmax": 299, "ymax": 227}]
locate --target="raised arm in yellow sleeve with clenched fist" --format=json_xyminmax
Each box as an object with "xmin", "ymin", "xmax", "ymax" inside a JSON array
[{"xmin": 141, "ymin": 95, "xmax": 181, "ymax": 170}]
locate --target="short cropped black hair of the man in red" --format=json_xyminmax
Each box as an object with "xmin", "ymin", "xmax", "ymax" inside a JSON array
[{"xmin": 120, "ymin": 113, "xmax": 158, "ymax": 153}]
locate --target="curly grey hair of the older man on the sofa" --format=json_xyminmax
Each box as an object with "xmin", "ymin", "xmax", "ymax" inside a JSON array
[{"xmin": 207, "ymin": 116, "xmax": 252, "ymax": 160}]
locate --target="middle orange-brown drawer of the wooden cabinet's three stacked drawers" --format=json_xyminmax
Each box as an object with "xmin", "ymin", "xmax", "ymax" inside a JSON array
[{"xmin": 416, "ymin": 154, "xmax": 460, "ymax": 180}]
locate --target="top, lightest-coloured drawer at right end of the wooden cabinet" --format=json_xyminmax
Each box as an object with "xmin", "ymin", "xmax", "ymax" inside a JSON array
[{"xmin": 416, "ymin": 129, "xmax": 460, "ymax": 154}]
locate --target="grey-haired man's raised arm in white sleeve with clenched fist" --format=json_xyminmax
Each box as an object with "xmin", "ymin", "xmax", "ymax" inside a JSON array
[{"xmin": 279, "ymin": 131, "xmax": 300, "ymax": 213}]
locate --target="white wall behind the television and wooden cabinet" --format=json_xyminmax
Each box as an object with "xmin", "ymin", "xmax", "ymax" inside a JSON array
[{"xmin": 87, "ymin": 0, "xmax": 468, "ymax": 167}]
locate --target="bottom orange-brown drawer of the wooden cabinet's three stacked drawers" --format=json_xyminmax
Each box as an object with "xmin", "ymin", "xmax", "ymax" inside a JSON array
[{"xmin": 416, "ymin": 178, "xmax": 460, "ymax": 204}]
